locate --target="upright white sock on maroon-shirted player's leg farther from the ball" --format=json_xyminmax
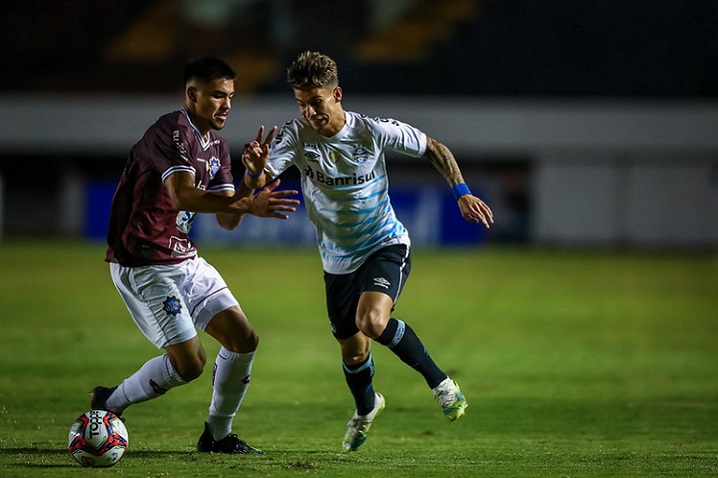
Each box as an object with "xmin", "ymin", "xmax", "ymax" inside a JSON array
[{"xmin": 207, "ymin": 347, "xmax": 254, "ymax": 440}]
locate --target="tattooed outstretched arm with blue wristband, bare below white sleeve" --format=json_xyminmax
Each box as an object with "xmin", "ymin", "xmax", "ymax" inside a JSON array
[{"xmin": 425, "ymin": 136, "xmax": 494, "ymax": 228}]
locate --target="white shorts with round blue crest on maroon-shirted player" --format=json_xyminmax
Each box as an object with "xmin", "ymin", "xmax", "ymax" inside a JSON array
[{"xmin": 110, "ymin": 257, "xmax": 239, "ymax": 348}]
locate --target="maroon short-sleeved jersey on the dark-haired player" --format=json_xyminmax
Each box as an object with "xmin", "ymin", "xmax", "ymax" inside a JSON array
[{"xmin": 106, "ymin": 110, "xmax": 234, "ymax": 267}]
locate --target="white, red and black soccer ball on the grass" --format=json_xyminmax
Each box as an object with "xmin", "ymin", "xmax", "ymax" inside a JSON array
[{"xmin": 67, "ymin": 410, "xmax": 130, "ymax": 467}]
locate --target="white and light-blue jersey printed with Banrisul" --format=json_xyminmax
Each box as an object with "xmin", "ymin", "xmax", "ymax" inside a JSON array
[{"xmin": 267, "ymin": 111, "xmax": 426, "ymax": 274}]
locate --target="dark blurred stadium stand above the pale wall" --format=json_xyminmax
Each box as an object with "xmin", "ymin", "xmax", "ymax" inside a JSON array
[{"xmin": 0, "ymin": 0, "xmax": 718, "ymax": 97}]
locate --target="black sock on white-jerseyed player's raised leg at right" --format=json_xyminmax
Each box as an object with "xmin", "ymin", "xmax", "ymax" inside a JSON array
[{"xmin": 377, "ymin": 319, "xmax": 446, "ymax": 388}]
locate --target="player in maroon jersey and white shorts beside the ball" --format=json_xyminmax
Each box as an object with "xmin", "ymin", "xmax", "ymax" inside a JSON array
[{"xmin": 91, "ymin": 57, "xmax": 299, "ymax": 454}]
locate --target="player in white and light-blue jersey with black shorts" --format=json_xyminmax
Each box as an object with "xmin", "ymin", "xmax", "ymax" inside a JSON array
[{"xmin": 243, "ymin": 52, "xmax": 493, "ymax": 450}]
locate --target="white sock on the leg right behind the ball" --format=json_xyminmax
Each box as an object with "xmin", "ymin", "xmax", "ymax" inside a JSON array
[{"xmin": 105, "ymin": 355, "xmax": 187, "ymax": 413}]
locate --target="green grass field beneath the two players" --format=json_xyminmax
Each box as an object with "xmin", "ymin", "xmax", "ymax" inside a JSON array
[{"xmin": 0, "ymin": 241, "xmax": 718, "ymax": 478}]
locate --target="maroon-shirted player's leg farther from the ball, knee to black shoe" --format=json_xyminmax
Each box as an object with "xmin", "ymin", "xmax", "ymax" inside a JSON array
[{"xmin": 197, "ymin": 306, "xmax": 262, "ymax": 454}]
